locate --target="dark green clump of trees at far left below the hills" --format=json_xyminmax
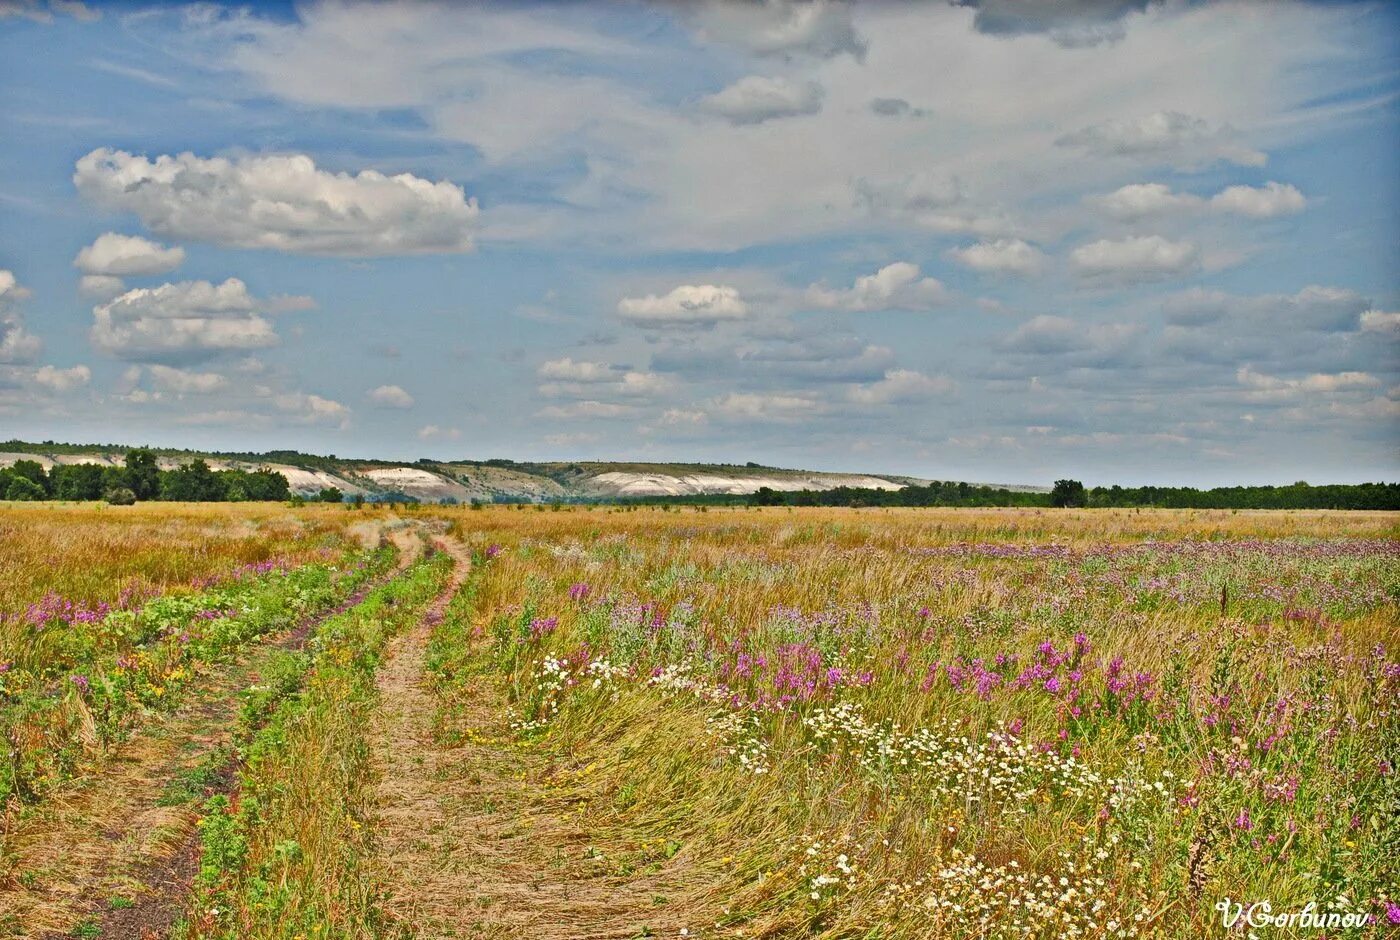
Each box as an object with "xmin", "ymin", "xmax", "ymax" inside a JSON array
[{"xmin": 0, "ymin": 447, "xmax": 298, "ymax": 506}]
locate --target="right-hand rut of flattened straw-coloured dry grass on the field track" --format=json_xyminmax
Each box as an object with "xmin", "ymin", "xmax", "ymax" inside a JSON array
[{"xmin": 371, "ymin": 542, "xmax": 705, "ymax": 940}]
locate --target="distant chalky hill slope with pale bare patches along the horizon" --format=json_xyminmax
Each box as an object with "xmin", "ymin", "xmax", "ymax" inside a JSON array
[{"xmin": 0, "ymin": 441, "xmax": 1047, "ymax": 503}]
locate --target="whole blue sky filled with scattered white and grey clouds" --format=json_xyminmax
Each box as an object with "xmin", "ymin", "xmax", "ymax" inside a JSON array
[{"xmin": 0, "ymin": 0, "xmax": 1400, "ymax": 486}]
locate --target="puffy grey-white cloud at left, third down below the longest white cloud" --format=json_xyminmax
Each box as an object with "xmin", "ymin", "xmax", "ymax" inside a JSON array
[{"xmin": 88, "ymin": 277, "xmax": 279, "ymax": 361}]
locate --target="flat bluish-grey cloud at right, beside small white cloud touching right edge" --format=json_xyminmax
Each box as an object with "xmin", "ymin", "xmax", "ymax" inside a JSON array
[{"xmin": 1162, "ymin": 284, "xmax": 1371, "ymax": 333}]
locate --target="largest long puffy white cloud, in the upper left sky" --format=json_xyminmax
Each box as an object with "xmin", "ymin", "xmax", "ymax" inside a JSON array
[{"xmin": 73, "ymin": 147, "xmax": 479, "ymax": 256}]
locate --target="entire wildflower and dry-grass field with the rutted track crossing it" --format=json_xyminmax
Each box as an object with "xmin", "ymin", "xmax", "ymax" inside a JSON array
[{"xmin": 0, "ymin": 504, "xmax": 1400, "ymax": 940}]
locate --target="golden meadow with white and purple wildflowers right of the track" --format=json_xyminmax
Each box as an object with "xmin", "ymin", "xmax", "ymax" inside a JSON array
[{"xmin": 437, "ymin": 510, "xmax": 1400, "ymax": 939}]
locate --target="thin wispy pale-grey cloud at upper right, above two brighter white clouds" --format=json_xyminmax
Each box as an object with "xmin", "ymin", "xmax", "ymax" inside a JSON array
[{"xmin": 1056, "ymin": 111, "xmax": 1268, "ymax": 168}]
